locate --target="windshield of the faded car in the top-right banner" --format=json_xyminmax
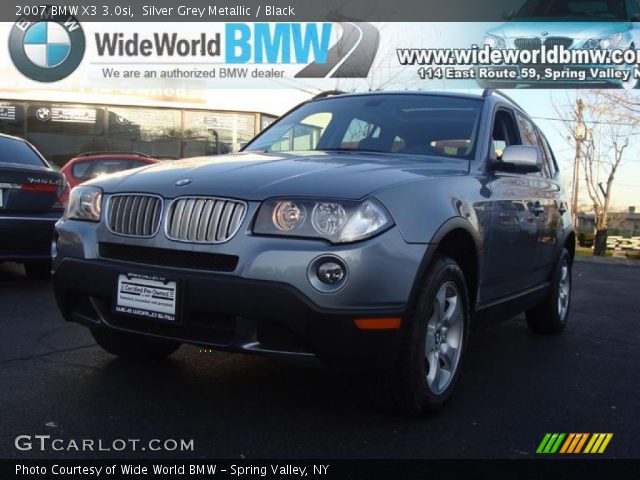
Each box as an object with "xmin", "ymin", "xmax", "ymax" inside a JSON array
[{"xmin": 514, "ymin": 0, "xmax": 627, "ymax": 21}]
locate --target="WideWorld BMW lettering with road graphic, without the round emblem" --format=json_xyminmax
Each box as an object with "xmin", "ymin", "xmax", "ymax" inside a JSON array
[{"xmin": 95, "ymin": 22, "xmax": 379, "ymax": 78}]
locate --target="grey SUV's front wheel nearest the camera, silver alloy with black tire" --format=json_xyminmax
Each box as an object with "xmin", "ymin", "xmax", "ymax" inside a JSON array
[{"xmin": 372, "ymin": 256, "xmax": 470, "ymax": 416}]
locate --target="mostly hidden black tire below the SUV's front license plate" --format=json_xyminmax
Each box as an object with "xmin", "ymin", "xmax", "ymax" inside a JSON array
[{"xmin": 91, "ymin": 328, "xmax": 180, "ymax": 360}]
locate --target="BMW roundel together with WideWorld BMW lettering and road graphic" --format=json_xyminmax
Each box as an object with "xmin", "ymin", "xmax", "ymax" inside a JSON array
[{"xmin": 9, "ymin": 8, "xmax": 379, "ymax": 82}]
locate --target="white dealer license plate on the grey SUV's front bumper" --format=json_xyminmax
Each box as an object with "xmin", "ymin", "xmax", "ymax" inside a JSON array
[{"xmin": 114, "ymin": 273, "xmax": 178, "ymax": 322}]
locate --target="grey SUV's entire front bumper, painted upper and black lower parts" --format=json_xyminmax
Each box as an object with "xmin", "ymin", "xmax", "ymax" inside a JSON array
[{"xmin": 53, "ymin": 222, "xmax": 430, "ymax": 371}]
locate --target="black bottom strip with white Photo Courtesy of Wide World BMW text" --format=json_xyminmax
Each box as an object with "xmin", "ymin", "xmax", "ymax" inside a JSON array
[{"xmin": 0, "ymin": 459, "xmax": 640, "ymax": 480}]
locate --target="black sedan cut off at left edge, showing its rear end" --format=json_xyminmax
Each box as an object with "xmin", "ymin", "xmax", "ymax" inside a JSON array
[{"xmin": 0, "ymin": 135, "xmax": 65, "ymax": 279}]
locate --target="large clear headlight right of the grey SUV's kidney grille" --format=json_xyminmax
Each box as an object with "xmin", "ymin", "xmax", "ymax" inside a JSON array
[{"xmin": 253, "ymin": 198, "xmax": 393, "ymax": 243}]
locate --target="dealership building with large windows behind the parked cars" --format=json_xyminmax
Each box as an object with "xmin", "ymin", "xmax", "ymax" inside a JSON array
[{"xmin": 0, "ymin": 93, "xmax": 276, "ymax": 166}]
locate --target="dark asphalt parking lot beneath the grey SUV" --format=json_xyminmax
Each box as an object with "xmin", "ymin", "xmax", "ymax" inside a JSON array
[{"xmin": 0, "ymin": 263, "xmax": 640, "ymax": 459}]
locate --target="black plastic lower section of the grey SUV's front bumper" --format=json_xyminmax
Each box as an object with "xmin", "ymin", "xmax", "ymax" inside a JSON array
[{"xmin": 53, "ymin": 258, "xmax": 405, "ymax": 370}]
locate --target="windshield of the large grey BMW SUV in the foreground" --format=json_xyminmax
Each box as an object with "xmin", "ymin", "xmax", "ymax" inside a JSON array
[{"xmin": 244, "ymin": 94, "xmax": 483, "ymax": 159}]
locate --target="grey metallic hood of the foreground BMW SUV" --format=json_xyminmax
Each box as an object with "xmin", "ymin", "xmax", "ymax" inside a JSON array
[{"xmin": 87, "ymin": 152, "xmax": 469, "ymax": 201}]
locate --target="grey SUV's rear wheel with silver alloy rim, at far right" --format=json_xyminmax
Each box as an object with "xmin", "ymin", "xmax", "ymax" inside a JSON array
[{"xmin": 526, "ymin": 248, "xmax": 572, "ymax": 333}]
